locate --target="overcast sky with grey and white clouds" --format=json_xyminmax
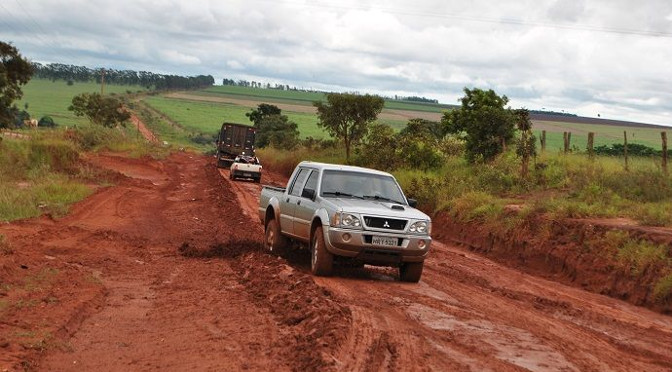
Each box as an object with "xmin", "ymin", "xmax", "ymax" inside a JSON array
[{"xmin": 0, "ymin": 0, "xmax": 672, "ymax": 125}]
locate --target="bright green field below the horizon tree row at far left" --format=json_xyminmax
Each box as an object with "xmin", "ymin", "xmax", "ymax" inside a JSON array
[{"xmin": 16, "ymin": 79, "xmax": 144, "ymax": 126}]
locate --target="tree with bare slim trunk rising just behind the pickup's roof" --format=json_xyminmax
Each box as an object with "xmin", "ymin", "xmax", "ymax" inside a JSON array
[{"xmin": 313, "ymin": 93, "xmax": 385, "ymax": 162}]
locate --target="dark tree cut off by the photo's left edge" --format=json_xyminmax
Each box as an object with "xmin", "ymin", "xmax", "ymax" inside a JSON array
[{"xmin": 0, "ymin": 41, "xmax": 33, "ymax": 128}]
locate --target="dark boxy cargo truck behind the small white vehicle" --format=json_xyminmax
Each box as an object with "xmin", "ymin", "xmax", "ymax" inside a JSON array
[{"xmin": 217, "ymin": 123, "xmax": 257, "ymax": 168}]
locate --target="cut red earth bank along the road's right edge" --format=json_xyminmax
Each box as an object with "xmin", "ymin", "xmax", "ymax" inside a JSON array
[{"xmin": 437, "ymin": 215, "xmax": 672, "ymax": 314}]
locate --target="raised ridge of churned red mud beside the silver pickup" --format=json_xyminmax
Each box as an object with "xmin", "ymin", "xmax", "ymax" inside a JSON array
[{"xmin": 179, "ymin": 240, "xmax": 351, "ymax": 371}]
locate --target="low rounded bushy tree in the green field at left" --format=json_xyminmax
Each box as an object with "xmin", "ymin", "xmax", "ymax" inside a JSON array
[{"xmin": 68, "ymin": 93, "xmax": 131, "ymax": 128}]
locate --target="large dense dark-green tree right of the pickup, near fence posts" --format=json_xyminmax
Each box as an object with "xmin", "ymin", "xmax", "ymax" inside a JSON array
[{"xmin": 441, "ymin": 88, "xmax": 515, "ymax": 162}]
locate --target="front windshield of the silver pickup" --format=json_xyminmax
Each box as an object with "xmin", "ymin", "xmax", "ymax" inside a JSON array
[{"xmin": 320, "ymin": 170, "xmax": 406, "ymax": 204}]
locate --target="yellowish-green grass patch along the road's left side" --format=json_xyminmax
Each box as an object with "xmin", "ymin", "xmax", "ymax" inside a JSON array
[{"xmin": 0, "ymin": 125, "xmax": 169, "ymax": 221}]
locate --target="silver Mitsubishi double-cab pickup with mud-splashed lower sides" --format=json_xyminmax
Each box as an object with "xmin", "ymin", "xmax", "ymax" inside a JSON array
[{"xmin": 259, "ymin": 161, "xmax": 432, "ymax": 282}]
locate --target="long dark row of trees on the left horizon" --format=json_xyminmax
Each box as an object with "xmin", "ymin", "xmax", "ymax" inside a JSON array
[{"xmin": 31, "ymin": 62, "xmax": 215, "ymax": 90}]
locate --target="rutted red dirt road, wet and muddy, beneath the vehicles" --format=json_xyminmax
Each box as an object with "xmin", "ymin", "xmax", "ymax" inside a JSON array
[{"xmin": 0, "ymin": 153, "xmax": 672, "ymax": 371}]
